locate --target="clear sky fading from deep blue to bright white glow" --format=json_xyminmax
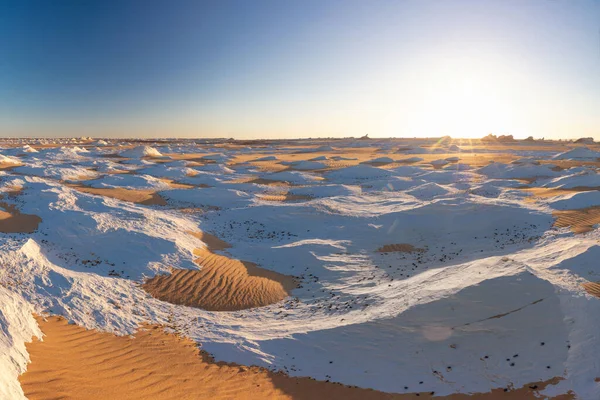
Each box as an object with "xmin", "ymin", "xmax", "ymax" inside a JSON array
[{"xmin": 0, "ymin": 0, "xmax": 600, "ymax": 139}]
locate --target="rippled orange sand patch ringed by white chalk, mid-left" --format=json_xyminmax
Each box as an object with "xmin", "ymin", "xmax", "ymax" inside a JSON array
[{"xmin": 142, "ymin": 249, "xmax": 296, "ymax": 311}]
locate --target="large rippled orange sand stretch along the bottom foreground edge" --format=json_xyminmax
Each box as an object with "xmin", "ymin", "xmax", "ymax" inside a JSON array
[{"xmin": 19, "ymin": 317, "xmax": 574, "ymax": 400}]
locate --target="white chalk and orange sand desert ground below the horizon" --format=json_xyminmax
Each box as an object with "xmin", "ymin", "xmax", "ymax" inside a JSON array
[{"xmin": 0, "ymin": 138, "xmax": 600, "ymax": 400}]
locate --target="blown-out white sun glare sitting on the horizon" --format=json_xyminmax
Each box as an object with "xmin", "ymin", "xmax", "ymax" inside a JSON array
[{"xmin": 397, "ymin": 55, "xmax": 526, "ymax": 138}]
